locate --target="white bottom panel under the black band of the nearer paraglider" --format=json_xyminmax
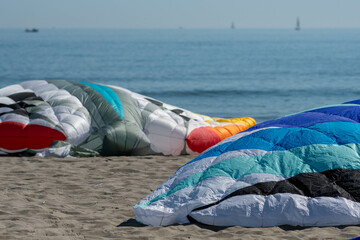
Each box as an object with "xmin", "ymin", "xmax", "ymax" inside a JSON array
[{"xmin": 190, "ymin": 193, "xmax": 360, "ymax": 227}]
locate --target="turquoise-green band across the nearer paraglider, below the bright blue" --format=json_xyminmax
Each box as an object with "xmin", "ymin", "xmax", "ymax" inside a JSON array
[{"xmin": 135, "ymin": 143, "xmax": 360, "ymax": 207}]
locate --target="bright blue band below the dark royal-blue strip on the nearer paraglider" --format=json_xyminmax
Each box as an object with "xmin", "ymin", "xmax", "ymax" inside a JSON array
[{"xmin": 189, "ymin": 122, "xmax": 360, "ymax": 163}]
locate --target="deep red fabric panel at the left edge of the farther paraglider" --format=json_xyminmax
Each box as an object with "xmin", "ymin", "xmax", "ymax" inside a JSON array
[{"xmin": 0, "ymin": 121, "xmax": 66, "ymax": 150}]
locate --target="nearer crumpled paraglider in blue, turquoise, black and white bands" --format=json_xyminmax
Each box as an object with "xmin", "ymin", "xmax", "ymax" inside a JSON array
[{"xmin": 134, "ymin": 100, "xmax": 360, "ymax": 227}]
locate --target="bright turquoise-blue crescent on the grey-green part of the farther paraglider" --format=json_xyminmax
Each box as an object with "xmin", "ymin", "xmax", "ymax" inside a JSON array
[{"xmin": 80, "ymin": 82, "xmax": 124, "ymax": 119}]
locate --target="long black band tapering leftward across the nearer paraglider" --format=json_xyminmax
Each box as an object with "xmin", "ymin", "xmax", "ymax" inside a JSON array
[{"xmin": 193, "ymin": 169, "xmax": 360, "ymax": 211}]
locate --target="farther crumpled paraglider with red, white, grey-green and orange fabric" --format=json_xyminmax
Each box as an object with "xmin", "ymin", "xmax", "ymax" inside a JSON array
[{"xmin": 0, "ymin": 80, "xmax": 255, "ymax": 157}]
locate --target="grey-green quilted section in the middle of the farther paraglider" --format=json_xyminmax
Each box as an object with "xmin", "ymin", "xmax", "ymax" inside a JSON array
[{"xmin": 49, "ymin": 80, "xmax": 152, "ymax": 156}]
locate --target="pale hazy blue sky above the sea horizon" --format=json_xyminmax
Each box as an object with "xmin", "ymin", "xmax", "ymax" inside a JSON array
[{"xmin": 0, "ymin": 0, "xmax": 360, "ymax": 29}]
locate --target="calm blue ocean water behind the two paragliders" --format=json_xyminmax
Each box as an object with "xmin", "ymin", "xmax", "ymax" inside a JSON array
[{"xmin": 0, "ymin": 29, "xmax": 360, "ymax": 122}]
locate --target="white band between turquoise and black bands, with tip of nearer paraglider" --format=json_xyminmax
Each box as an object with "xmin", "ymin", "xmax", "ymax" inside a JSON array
[{"xmin": 134, "ymin": 173, "xmax": 284, "ymax": 225}]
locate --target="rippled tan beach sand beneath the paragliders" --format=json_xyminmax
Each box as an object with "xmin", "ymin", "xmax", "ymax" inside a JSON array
[{"xmin": 0, "ymin": 156, "xmax": 360, "ymax": 239}]
